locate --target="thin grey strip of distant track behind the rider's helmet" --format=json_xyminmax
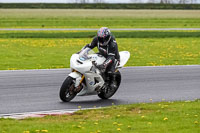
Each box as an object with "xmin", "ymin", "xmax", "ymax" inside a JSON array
[{"xmin": 0, "ymin": 28, "xmax": 200, "ymax": 31}]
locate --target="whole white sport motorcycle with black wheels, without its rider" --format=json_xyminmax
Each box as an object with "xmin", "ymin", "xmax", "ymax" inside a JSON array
[{"xmin": 60, "ymin": 48, "xmax": 130, "ymax": 102}]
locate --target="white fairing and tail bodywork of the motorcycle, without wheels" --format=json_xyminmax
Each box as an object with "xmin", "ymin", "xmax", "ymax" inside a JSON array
[{"xmin": 69, "ymin": 48, "xmax": 130, "ymax": 96}]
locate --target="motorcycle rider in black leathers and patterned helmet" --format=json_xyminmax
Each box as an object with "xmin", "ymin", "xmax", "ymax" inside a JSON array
[{"xmin": 84, "ymin": 27, "xmax": 120, "ymax": 88}]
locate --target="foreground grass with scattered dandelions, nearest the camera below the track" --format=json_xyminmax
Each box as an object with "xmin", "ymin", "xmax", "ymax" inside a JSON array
[{"xmin": 0, "ymin": 100, "xmax": 200, "ymax": 133}]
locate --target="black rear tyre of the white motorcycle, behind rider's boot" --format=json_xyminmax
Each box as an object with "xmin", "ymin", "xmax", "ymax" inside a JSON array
[{"xmin": 98, "ymin": 71, "xmax": 121, "ymax": 99}]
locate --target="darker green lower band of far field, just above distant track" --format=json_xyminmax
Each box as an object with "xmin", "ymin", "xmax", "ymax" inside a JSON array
[{"xmin": 0, "ymin": 18, "xmax": 200, "ymax": 28}]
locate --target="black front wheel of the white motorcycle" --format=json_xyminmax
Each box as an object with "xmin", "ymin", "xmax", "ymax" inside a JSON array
[{"xmin": 60, "ymin": 76, "xmax": 77, "ymax": 102}]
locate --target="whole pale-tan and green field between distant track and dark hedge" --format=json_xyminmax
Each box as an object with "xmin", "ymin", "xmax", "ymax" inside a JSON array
[{"xmin": 0, "ymin": 9, "xmax": 200, "ymax": 28}]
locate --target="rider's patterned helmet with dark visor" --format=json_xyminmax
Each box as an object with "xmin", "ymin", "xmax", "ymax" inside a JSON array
[{"xmin": 97, "ymin": 27, "xmax": 111, "ymax": 46}]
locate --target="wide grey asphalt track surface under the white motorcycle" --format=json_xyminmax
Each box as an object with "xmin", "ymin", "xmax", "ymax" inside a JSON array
[{"xmin": 0, "ymin": 66, "xmax": 200, "ymax": 114}]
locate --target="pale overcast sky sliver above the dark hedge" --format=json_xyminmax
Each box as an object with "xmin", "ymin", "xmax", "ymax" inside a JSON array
[{"xmin": 0, "ymin": 0, "xmax": 200, "ymax": 3}]
